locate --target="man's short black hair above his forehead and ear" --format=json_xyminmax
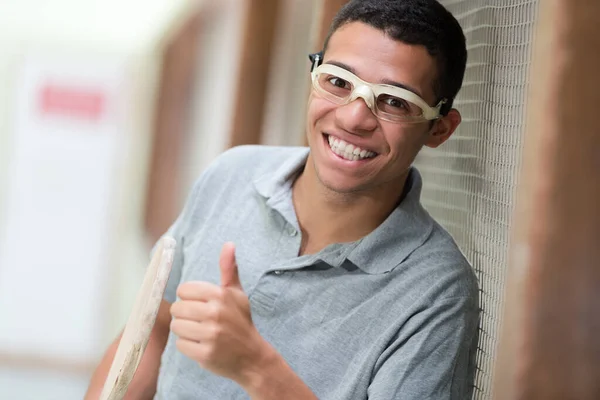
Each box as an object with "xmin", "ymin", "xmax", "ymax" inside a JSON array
[{"xmin": 323, "ymin": 0, "xmax": 467, "ymax": 115}]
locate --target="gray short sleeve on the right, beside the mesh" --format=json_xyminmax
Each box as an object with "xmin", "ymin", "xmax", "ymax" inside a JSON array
[{"xmin": 368, "ymin": 296, "xmax": 479, "ymax": 400}]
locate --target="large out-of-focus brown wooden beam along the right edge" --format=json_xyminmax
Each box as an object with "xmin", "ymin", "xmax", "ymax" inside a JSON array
[{"xmin": 494, "ymin": 0, "xmax": 600, "ymax": 400}]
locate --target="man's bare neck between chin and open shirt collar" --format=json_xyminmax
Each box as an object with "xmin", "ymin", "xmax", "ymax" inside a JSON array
[{"xmin": 293, "ymin": 155, "xmax": 408, "ymax": 253}]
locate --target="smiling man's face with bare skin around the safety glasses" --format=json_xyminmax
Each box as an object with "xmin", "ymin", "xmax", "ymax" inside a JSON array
[{"xmin": 307, "ymin": 22, "xmax": 460, "ymax": 193}]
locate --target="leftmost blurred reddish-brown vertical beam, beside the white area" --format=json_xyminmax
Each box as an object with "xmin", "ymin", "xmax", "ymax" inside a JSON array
[{"xmin": 145, "ymin": 10, "xmax": 201, "ymax": 243}]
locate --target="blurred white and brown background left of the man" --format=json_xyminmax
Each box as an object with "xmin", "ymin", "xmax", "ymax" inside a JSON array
[{"xmin": 0, "ymin": 0, "xmax": 317, "ymax": 400}]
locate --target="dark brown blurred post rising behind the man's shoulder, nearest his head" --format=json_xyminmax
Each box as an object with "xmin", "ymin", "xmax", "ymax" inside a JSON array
[{"xmin": 229, "ymin": 0, "xmax": 281, "ymax": 146}]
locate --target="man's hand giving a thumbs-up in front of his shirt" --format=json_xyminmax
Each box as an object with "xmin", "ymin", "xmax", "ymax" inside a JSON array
[{"xmin": 171, "ymin": 243, "xmax": 269, "ymax": 386}]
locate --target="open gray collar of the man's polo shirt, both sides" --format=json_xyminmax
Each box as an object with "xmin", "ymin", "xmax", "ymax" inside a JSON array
[{"xmin": 254, "ymin": 148, "xmax": 434, "ymax": 274}]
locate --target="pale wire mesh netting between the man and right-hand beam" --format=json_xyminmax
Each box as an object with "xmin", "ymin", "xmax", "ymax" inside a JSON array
[{"xmin": 416, "ymin": 0, "xmax": 538, "ymax": 399}]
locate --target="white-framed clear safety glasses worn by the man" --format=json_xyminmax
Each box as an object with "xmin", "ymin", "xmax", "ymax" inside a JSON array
[{"xmin": 311, "ymin": 54, "xmax": 446, "ymax": 122}]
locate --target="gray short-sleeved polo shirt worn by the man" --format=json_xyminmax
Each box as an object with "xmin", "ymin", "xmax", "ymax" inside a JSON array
[{"xmin": 155, "ymin": 146, "xmax": 479, "ymax": 400}]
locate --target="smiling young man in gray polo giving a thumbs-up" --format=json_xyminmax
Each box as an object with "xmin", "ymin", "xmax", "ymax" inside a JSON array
[{"xmin": 87, "ymin": 0, "xmax": 478, "ymax": 400}]
